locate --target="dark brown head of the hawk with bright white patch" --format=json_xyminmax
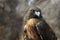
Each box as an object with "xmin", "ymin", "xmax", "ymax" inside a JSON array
[{"xmin": 28, "ymin": 8, "xmax": 42, "ymax": 19}]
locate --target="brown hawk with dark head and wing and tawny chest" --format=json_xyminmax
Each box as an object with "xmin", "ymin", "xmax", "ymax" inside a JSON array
[{"xmin": 24, "ymin": 8, "xmax": 57, "ymax": 40}]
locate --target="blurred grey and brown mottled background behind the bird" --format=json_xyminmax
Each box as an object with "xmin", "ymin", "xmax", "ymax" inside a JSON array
[{"xmin": 0, "ymin": 0, "xmax": 60, "ymax": 40}]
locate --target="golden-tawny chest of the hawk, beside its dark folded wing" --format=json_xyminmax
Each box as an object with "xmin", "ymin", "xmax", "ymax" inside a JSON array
[{"xmin": 25, "ymin": 19, "xmax": 39, "ymax": 40}]
